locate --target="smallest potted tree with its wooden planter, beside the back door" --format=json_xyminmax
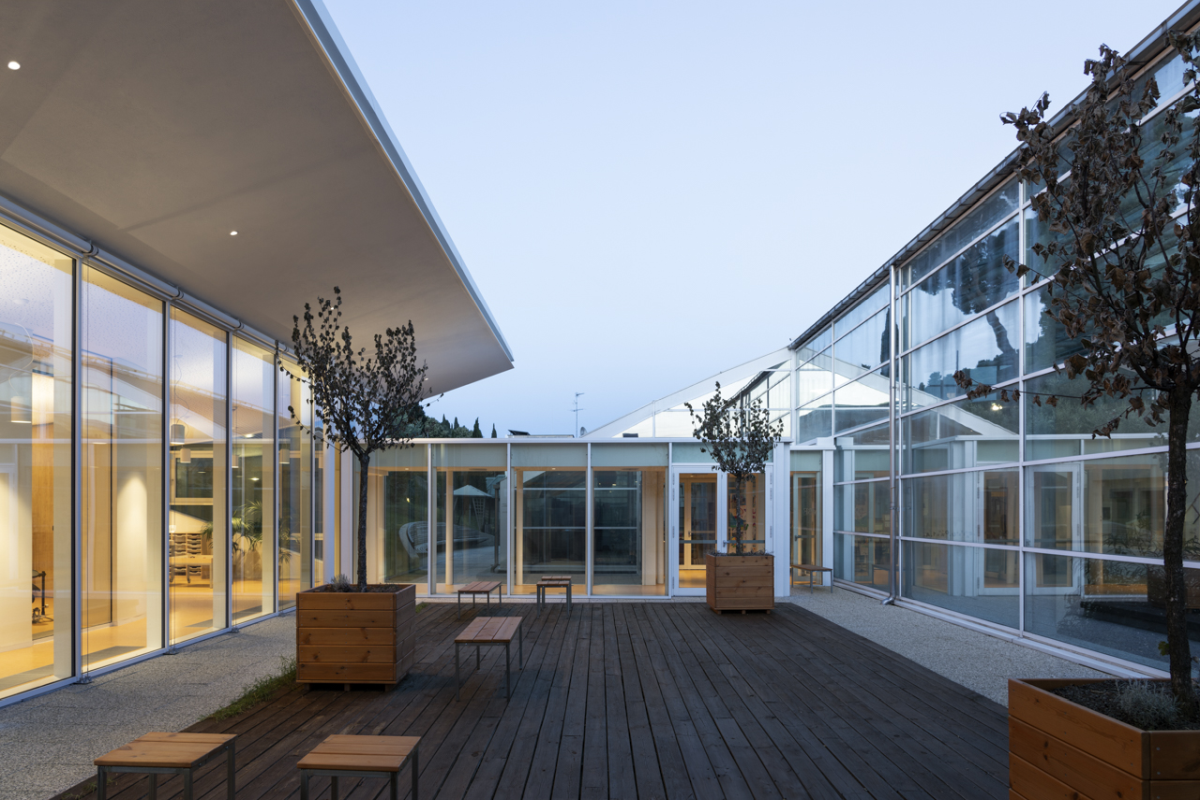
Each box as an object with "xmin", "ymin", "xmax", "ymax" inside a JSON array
[{"xmin": 684, "ymin": 383, "xmax": 784, "ymax": 614}]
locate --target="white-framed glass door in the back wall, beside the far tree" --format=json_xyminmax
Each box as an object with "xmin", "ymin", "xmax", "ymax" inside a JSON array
[{"xmin": 671, "ymin": 468, "xmax": 726, "ymax": 595}]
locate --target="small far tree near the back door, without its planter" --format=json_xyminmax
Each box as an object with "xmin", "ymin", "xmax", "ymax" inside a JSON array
[{"xmin": 684, "ymin": 383, "xmax": 784, "ymax": 555}]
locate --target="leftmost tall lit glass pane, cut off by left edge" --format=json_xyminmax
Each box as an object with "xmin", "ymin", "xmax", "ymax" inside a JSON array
[{"xmin": 0, "ymin": 228, "xmax": 74, "ymax": 698}]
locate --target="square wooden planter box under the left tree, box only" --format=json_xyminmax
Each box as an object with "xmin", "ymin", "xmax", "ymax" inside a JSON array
[{"xmin": 296, "ymin": 583, "xmax": 416, "ymax": 684}]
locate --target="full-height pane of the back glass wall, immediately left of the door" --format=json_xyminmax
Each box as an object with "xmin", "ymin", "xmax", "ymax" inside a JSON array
[{"xmin": 592, "ymin": 469, "xmax": 667, "ymax": 595}]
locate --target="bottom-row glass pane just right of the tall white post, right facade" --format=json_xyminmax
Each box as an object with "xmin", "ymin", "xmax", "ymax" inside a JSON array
[{"xmin": 901, "ymin": 542, "xmax": 1021, "ymax": 627}]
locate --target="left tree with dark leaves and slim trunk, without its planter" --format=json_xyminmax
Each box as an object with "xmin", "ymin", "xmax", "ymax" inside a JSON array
[{"xmin": 288, "ymin": 287, "xmax": 427, "ymax": 591}]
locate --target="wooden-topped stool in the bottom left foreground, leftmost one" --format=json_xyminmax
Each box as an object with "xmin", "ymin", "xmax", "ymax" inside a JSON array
[{"xmin": 92, "ymin": 733, "xmax": 236, "ymax": 800}]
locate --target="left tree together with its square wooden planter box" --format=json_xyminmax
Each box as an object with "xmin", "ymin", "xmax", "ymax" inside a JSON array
[{"xmin": 283, "ymin": 287, "xmax": 426, "ymax": 685}]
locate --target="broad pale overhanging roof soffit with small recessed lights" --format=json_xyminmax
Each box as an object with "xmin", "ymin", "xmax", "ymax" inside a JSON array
[{"xmin": 0, "ymin": 0, "xmax": 512, "ymax": 392}]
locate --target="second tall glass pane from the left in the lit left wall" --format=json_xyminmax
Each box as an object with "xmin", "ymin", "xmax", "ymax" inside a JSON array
[{"xmin": 82, "ymin": 269, "xmax": 164, "ymax": 669}]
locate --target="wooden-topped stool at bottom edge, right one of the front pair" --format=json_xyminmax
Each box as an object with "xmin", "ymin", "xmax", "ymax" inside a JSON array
[{"xmin": 296, "ymin": 734, "xmax": 421, "ymax": 800}]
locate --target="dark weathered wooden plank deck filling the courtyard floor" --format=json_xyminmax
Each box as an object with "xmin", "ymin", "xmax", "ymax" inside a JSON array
[{"xmin": 56, "ymin": 603, "xmax": 1008, "ymax": 800}]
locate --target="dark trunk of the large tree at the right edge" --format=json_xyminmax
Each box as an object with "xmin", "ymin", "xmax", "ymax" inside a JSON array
[{"xmin": 1163, "ymin": 389, "xmax": 1196, "ymax": 715}]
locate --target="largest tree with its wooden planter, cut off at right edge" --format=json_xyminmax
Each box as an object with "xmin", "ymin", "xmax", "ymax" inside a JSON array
[{"xmin": 955, "ymin": 32, "xmax": 1200, "ymax": 800}]
